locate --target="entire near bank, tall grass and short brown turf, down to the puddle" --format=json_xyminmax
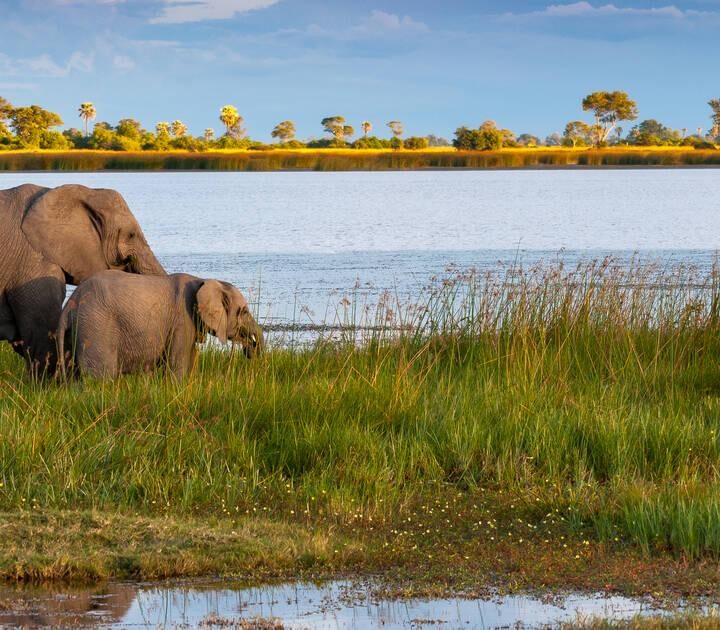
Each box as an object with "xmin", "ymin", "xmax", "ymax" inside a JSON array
[{"xmin": 5, "ymin": 261, "xmax": 720, "ymax": 590}]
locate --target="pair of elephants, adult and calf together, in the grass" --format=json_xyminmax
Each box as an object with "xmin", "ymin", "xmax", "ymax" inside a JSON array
[{"xmin": 0, "ymin": 184, "xmax": 263, "ymax": 378}]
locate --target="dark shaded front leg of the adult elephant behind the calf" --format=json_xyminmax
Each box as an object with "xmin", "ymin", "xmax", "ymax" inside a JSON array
[{"xmin": 7, "ymin": 276, "xmax": 65, "ymax": 377}]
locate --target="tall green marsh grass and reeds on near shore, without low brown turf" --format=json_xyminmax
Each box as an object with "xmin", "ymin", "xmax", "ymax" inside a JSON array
[{"xmin": 0, "ymin": 259, "xmax": 720, "ymax": 558}]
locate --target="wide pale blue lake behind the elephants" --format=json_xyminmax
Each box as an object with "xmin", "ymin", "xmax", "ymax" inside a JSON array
[{"xmin": 0, "ymin": 169, "xmax": 720, "ymax": 323}]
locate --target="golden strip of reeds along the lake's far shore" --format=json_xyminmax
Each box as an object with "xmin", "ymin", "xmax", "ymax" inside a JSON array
[{"xmin": 0, "ymin": 147, "xmax": 720, "ymax": 171}]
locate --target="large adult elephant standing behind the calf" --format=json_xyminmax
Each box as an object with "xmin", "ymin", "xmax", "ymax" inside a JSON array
[{"xmin": 0, "ymin": 184, "xmax": 165, "ymax": 376}]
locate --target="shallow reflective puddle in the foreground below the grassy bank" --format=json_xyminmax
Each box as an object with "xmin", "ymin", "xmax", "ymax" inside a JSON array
[{"xmin": 0, "ymin": 581, "xmax": 680, "ymax": 629}]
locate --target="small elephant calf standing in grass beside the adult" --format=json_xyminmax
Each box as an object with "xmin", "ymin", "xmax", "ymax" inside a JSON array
[{"xmin": 57, "ymin": 271, "xmax": 263, "ymax": 378}]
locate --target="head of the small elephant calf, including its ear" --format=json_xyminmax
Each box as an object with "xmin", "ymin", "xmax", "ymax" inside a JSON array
[{"xmin": 196, "ymin": 280, "xmax": 263, "ymax": 359}]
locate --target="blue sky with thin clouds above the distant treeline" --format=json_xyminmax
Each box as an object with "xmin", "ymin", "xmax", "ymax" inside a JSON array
[{"xmin": 0, "ymin": 0, "xmax": 720, "ymax": 139}]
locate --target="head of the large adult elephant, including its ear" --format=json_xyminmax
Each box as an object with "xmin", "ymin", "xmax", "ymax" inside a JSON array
[{"xmin": 21, "ymin": 185, "xmax": 165, "ymax": 284}]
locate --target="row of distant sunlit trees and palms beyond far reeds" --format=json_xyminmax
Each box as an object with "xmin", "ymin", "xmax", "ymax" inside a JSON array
[{"xmin": 0, "ymin": 91, "xmax": 720, "ymax": 152}]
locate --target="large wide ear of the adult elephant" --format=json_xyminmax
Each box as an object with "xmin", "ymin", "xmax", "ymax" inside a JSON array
[{"xmin": 21, "ymin": 185, "xmax": 111, "ymax": 284}]
